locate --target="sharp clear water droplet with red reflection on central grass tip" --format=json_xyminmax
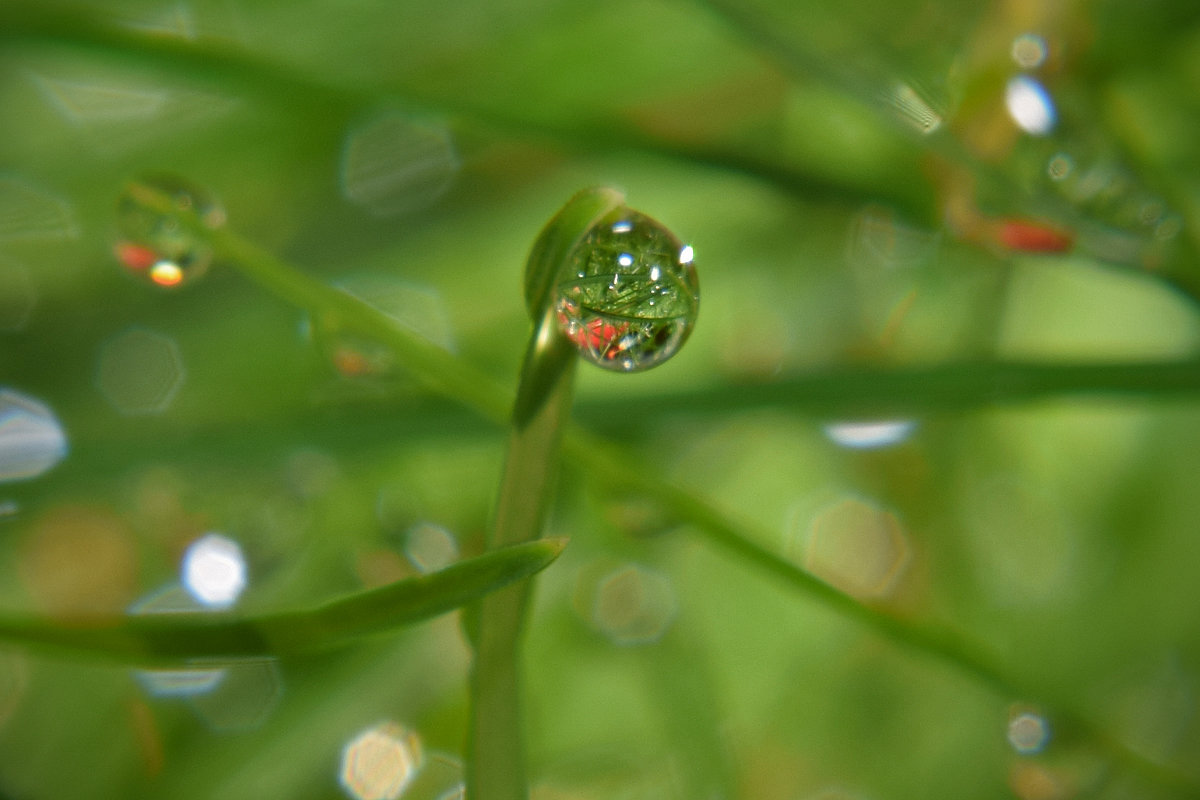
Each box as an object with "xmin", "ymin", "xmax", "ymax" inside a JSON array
[{"xmin": 554, "ymin": 209, "xmax": 700, "ymax": 372}]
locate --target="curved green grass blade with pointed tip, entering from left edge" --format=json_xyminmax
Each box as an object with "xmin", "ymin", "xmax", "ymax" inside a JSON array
[{"xmin": 0, "ymin": 539, "xmax": 566, "ymax": 664}]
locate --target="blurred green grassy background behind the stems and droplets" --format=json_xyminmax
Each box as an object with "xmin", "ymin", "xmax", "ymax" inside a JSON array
[{"xmin": 0, "ymin": 0, "xmax": 1200, "ymax": 800}]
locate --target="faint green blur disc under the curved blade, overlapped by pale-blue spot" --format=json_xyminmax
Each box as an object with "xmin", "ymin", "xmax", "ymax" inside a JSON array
[{"xmin": 187, "ymin": 658, "xmax": 283, "ymax": 733}]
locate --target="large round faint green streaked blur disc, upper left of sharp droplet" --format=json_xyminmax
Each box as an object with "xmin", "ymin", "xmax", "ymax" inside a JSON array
[{"xmin": 341, "ymin": 113, "xmax": 461, "ymax": 217}]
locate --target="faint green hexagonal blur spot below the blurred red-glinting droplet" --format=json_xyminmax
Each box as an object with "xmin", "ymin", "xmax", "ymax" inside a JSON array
[{"xmin": 96, "ymin": 327, "xmax": 186, "ymax": 416}]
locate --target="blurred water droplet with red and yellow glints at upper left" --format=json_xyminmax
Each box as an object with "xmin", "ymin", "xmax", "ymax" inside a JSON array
[{"xmin": 113, "ymin": 176, "xmax": 226, "ymax": 289}]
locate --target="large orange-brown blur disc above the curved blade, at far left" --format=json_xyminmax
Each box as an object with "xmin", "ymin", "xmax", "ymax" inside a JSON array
[{"xmin": 18, "ymin": 505, "xmax": 138, "ymax": 616}]
